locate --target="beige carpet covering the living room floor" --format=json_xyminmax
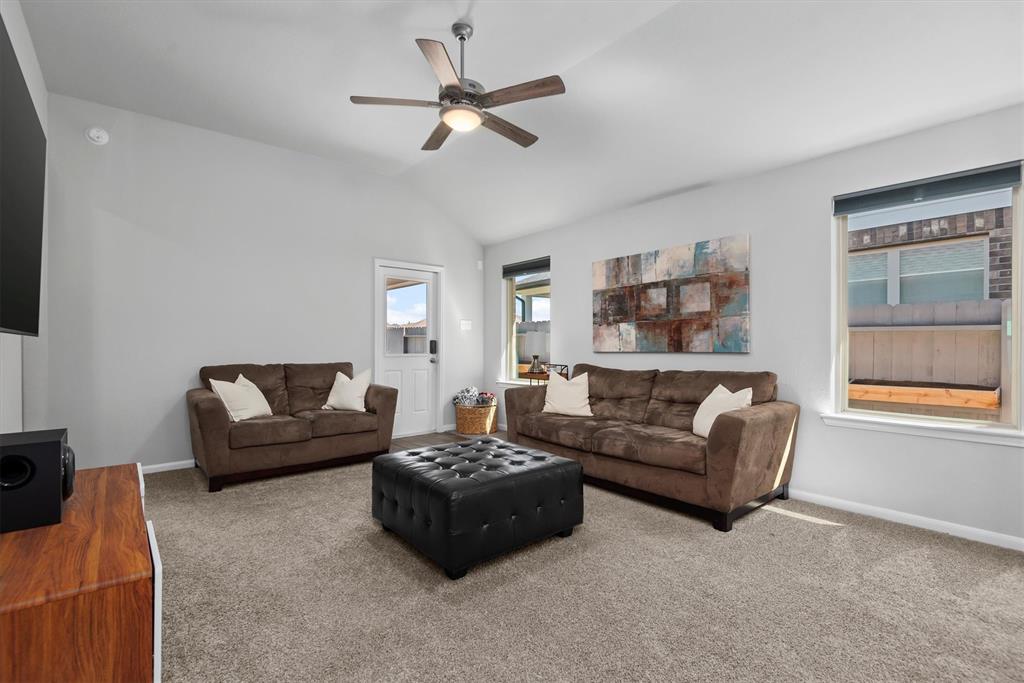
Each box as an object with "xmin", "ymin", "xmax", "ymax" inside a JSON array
[{"xmin": 146, "ymin": 464, "xmax": 1024, "ymax": 681}]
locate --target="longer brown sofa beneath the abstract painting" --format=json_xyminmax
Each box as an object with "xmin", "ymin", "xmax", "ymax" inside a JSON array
[{"xmin": 505, "ymin": 364, "xmax": 800, "ymax": 531}]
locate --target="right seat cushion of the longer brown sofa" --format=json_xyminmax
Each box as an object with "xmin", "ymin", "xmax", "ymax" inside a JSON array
[{"xmin": 593, "ymin": 425, "xmax": 708, "ymax": 474}]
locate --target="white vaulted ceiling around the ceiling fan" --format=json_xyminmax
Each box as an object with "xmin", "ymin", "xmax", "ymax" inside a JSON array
[{"xmin": 22, "ymin": 0, "xmax": 1024, "ymax": 243}]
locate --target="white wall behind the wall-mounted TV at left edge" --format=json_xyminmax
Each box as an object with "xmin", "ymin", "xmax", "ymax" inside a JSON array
[{"xmin": 0, "ymin": 0, "xmax": 47, "ymax": 432}]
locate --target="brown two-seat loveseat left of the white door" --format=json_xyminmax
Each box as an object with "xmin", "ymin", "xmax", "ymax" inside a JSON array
[{"xmin": 185, "ymin": 362, "xmax": 398, "ymax": 492}]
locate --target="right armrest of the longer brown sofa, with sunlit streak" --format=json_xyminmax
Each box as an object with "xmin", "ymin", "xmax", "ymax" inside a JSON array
[{"xmin": 708, "ymin": 400, "xmax": 800, "ymax": 512}]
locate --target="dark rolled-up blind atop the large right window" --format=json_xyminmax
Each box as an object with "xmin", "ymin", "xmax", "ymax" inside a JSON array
[{"xmin": 833, "ymin": 160, "xmax": 1021, "ymax": 216}]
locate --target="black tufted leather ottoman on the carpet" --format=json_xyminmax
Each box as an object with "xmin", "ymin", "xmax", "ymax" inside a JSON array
[{"xmin": 372, "ymin": 437, "xmax": 583, "ymax": 579}]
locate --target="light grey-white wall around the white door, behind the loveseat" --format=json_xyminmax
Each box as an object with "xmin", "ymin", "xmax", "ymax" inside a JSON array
[{"xmin": 25, "ymin": 94, "xmax": 483, "ymax": 467}]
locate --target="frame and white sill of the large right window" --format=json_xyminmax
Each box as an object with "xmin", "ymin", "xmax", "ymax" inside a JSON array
[{"xmin": 821, "ymin": 184, "xmax": 1024, "ymax": 445}]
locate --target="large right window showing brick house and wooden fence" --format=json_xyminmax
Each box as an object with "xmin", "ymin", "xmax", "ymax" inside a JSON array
[{"xmin": 835, "ymin": 163, "xmax": 1021, "ymax": 426}]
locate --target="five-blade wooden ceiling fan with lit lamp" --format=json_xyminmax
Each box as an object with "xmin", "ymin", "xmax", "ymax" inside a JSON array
[{"xmin": 349, "ymin": 22, "xmax": 565, "ymax": 151}]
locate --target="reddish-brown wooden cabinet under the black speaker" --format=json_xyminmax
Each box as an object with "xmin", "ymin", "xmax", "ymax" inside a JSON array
[{"xmin": 0, "ymin": 465, "xmax": 160, "ymax": 682}]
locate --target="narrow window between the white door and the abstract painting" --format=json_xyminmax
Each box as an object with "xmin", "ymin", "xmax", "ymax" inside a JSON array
[{"xmin": 502, "ymin": 258, "xmax": 551, "ymax": 380}]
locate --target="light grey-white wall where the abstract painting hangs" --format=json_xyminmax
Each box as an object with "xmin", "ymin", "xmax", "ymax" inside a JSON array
[{"xmin": 484, "ymin": 106, "xmax": 1024, "ymax": 539}]
